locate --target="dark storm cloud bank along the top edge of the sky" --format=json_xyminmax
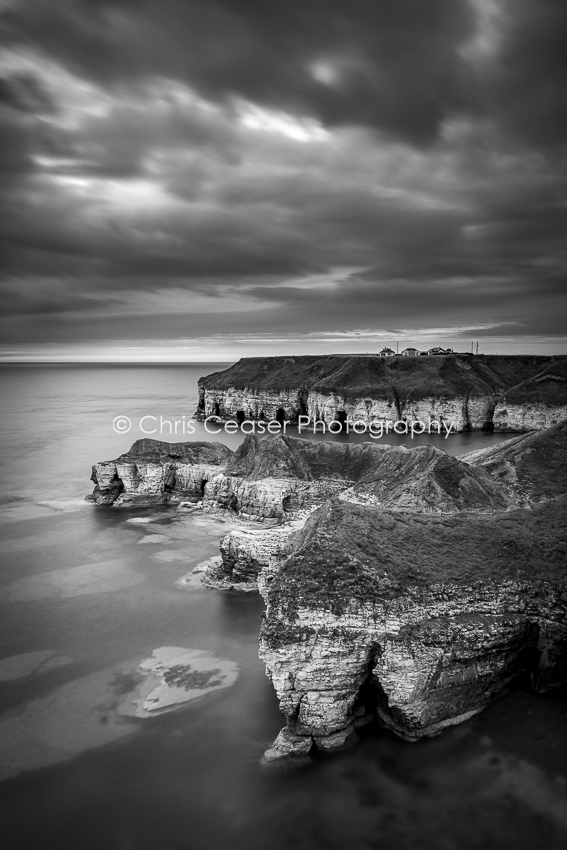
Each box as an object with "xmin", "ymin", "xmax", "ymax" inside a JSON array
[{"xmin": 3, "ymin": 0, "xmax": 474, "ymax": 144}]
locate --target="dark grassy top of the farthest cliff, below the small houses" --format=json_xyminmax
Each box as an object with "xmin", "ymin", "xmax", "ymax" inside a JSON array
[{"xmin": 199, "ymin": 354, "xmax": 567, "ymax": 404}]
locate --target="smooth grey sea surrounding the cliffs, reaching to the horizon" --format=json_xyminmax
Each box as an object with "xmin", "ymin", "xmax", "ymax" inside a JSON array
[{"xmin": 0, "ymin": 363, "xmax": 567, "ymax": 850}]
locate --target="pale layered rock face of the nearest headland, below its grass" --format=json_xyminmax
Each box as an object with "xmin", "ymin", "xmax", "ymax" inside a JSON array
[{"xmin": 260, "ymin": 575, "xmax": 567, "ymax": 760}]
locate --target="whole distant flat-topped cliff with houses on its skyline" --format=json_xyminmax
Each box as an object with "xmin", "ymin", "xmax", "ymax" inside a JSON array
[{"xmin": 196, "ymin": 354, "xmax": 567, "ymax": 432}]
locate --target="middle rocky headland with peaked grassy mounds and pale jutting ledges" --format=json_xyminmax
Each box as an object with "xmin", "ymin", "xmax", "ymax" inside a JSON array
[{"xmin": 88, "ymin": 435, "xmax": 508, "ymax": 589}]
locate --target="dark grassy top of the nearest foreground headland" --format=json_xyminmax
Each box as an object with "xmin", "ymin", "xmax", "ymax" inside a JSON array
[{"xmin": 269, "ymin": 496, "xmax": 567, "ymax": 612}]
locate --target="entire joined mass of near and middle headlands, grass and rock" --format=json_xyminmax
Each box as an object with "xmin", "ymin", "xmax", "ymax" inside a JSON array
[{"xmin": 91, "ymin": 422, "xmax": 567, "ymax": 760}]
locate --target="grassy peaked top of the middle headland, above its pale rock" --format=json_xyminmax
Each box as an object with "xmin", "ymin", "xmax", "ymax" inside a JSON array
[{"xmin": 97, "ymin": 422, "xmax": 567, "ymax": 513}]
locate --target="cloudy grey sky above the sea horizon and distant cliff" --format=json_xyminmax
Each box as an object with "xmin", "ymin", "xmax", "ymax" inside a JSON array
[{"xmin": 0, "ymin": 0, "xmax": 567, "ymax": 361}]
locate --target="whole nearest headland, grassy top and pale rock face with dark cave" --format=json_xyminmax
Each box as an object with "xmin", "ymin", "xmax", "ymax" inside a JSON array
[{"xmin": 260, "ymin": 497, "xmax": 567, "ymax": 759}]
